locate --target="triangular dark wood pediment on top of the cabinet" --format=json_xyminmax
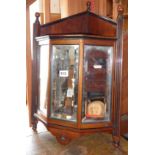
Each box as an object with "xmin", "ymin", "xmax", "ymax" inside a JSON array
[{"xmin": 36, "ymin": 11, "xmax": 117, "ymax": 38}]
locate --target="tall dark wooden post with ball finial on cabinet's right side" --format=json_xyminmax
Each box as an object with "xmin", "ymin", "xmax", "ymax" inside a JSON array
[{"xmin": 113, "ymin": 5, "xmax": 123, "ymax": 147}]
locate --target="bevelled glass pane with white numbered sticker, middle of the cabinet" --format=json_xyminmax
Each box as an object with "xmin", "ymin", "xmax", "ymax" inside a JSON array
[{"xmin": 51, "ymin": 45, "xmax": 79, "ymax": 122}]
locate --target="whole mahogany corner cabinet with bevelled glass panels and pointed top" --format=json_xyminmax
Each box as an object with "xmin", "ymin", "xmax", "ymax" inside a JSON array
[{"xmin": 31, "ymin": 3, "xmax": 123, "ymax": 147}]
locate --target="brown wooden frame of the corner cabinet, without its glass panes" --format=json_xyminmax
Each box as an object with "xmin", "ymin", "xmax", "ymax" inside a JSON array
[{"xmin": 32, "ymin": 3, "xmax": 123, "ymax": 147}]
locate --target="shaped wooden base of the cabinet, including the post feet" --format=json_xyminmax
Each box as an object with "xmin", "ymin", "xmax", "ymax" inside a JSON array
[{"xmin": 33, "ymin": 114, "xmax": 120, "ymax": 147}]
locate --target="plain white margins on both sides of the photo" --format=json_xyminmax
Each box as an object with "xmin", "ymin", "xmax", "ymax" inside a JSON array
[{"xmin": 0, "ymin": 0, "xmax": 155, "ymax": 155}]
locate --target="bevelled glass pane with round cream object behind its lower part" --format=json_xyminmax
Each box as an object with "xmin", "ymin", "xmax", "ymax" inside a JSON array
[{"xmin": 82, "ymin": 45, "xmax": 113, "ymax": 123}]
